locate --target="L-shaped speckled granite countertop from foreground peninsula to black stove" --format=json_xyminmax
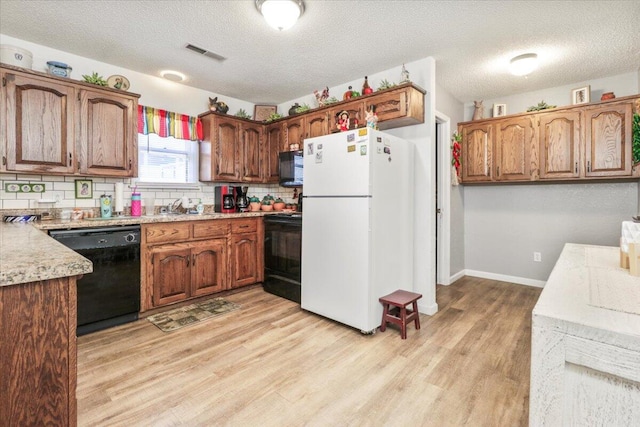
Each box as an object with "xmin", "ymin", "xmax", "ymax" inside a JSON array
[{"xmin": 0, "ymin": 211, "xmax": 280, "ymax": 286}]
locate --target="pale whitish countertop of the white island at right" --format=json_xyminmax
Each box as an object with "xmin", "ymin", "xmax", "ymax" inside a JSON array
[{"xmin": 533, "ymin": 243, "xmax": 640, "ymax": 351}]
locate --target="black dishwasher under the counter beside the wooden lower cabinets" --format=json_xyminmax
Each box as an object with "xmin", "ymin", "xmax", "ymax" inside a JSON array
[{"xmin": 49, "ymin": 225, "xmax": 140, "ymax": 336}]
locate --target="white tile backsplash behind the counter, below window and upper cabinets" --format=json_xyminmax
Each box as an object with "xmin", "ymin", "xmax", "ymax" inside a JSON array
[{"xmin": 0, "ymin": 173, "xmax": 297, "ymax": 214}]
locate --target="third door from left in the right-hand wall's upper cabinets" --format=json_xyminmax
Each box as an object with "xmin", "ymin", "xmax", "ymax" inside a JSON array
[{"xmin": 538, "ymin": 111, "xmax": 580, "ymax": 179}]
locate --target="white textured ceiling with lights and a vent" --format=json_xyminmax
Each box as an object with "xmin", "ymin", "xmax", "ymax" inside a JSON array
[{"xmin": 0, "ymin": 0, "xmax": 640, "ymax": 103}]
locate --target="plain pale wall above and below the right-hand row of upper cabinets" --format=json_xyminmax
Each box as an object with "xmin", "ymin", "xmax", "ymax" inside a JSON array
[{"xmin": 464, "ymin": 72, "xmax": 640, "ymax": 285}]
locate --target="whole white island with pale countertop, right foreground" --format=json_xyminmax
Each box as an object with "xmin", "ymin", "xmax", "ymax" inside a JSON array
[{"xmin": 529, "ymin": 243, "xmax": 640, "ymax": 426}]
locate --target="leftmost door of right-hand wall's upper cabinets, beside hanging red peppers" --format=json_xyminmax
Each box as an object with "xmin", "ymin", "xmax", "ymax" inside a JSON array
[{"xmin": 461, "ymin": 123, "xmax": 493, "ymax": 182}]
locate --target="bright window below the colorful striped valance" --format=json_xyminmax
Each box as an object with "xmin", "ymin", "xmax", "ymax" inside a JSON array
[{"xmin": 138, "ymin": 133, "xmax": 198, "ymax": 184}]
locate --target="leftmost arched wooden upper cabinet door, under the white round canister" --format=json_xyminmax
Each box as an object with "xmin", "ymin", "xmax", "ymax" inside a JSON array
[{"xmin": 5, "ymin": 72, "xmax": 76, "ymax": 175}]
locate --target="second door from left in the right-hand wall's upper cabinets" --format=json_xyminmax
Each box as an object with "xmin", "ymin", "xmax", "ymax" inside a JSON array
[{"xmin": 495, "ymin": 116, "xmax": 536, "ymax": 181}]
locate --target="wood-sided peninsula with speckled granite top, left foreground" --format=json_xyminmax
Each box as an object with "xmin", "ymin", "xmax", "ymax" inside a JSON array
[{"xmin": 0, "ymin": 223, "xmax": 92, "ymax": 426}]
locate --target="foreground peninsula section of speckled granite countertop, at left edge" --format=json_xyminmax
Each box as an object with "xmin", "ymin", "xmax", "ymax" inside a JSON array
[{"xmin": 0, "ymin": 223, "xmax": 93, "ymax": 286}]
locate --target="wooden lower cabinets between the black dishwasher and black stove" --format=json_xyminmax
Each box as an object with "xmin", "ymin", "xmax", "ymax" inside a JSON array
[{"xmin": 141, "ymin": 221, "xmax": 264, "ymax": 312}]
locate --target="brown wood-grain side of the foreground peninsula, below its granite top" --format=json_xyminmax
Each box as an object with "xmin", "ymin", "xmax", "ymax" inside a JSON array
[{"xmin": 0, "ymin": 277, "xmax": 77, "ymax": 427}]
